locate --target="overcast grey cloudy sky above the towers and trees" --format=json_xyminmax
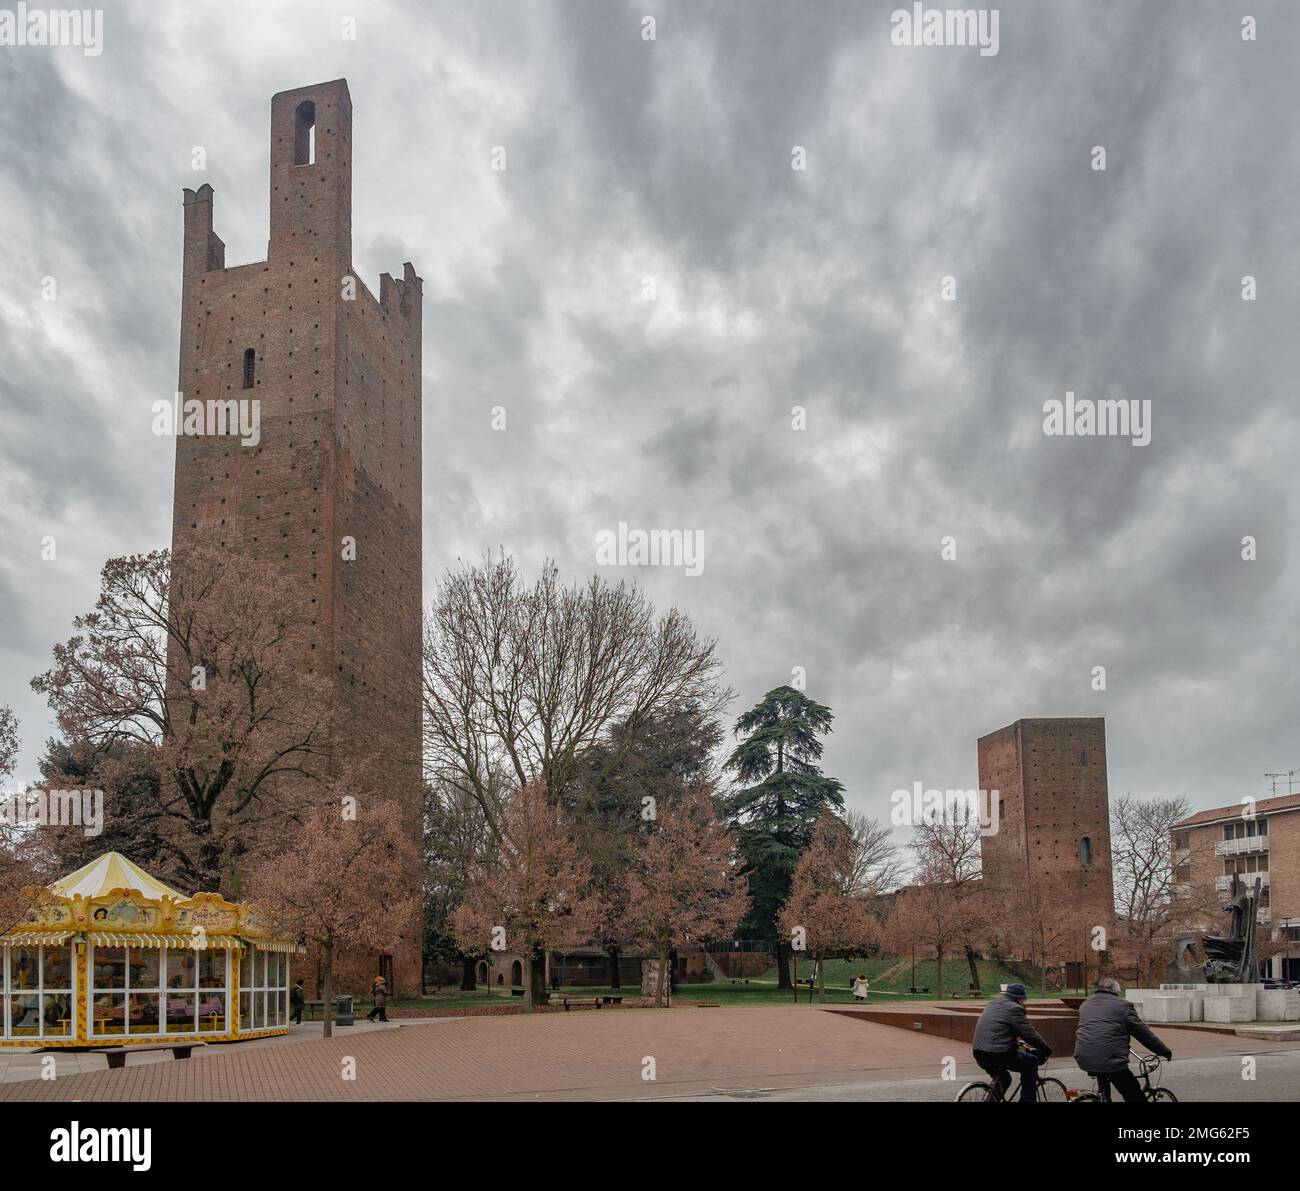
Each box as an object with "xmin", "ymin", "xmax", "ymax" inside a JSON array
[{"xmin": 0, "ymin": 0, "xmax": 1300, "ymax": 837}]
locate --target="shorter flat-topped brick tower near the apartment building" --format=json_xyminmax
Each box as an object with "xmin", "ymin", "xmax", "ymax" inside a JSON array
[{"xmin": 979, "ymin": 718, "xmax": 1114, "ymax": 930}]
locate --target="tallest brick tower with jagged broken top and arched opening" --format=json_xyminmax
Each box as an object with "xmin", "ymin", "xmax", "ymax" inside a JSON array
[{"xmin": 172, "ymin": 79, "xmax": 421, "ymax": 992}]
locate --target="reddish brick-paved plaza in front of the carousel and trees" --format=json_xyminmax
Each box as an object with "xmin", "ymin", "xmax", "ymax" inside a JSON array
[{"xmin": 0, "ymin": 1006, "xmax": 1300, "ymax": 1101}]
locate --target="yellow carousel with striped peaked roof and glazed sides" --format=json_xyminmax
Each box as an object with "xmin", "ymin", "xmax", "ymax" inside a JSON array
[{"xmin": 0, "ymin": 852, "xmax": 304, "ymax": 1048}]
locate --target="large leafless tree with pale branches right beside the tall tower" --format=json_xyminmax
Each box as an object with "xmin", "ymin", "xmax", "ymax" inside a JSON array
[{"xmin": 424, "ymin": 554, "xmax": 731, "ymax": 835}]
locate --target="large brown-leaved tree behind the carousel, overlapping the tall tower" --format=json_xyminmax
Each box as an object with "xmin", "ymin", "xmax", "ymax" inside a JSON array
[{"xmin": 31, "ymin": 547, "xmax": 328, "ymax": 889}]
